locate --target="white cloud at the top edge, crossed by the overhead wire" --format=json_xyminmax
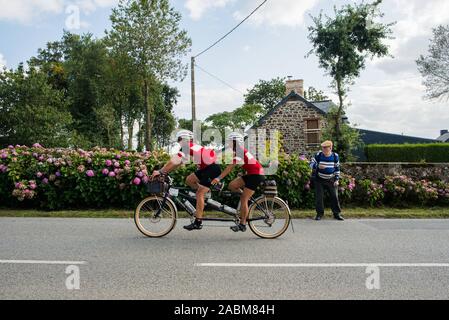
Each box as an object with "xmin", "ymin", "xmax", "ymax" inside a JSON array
[{"xmin": 234, "ymin": 0, "xmax": 320, "ymax": 27}]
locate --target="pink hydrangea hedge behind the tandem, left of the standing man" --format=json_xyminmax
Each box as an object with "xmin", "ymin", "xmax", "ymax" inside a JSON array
[{"xmin": 0, "ymin": 144, "xmax": 313, "ymax": 210}]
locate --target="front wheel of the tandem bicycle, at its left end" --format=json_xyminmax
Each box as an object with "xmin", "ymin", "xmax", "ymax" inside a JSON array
[{"xmin": 134, "ymin": 196, "xmax": 178, "ymax": 238}]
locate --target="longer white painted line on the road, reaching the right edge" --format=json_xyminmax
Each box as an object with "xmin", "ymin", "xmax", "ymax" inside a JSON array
[{"xmin": 195, "ymin": 263, "xmax": 449, "ymax": 268}]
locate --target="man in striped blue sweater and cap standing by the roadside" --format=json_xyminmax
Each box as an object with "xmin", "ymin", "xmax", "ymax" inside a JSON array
[{"xmin": 310, "ymin": 141, "xmax": 344, "ymax": 221}]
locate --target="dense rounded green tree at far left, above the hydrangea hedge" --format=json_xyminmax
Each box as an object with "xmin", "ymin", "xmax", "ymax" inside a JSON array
[{"xmin": 0, "ymin": 64, "xmax": 74, "ymax": 147}]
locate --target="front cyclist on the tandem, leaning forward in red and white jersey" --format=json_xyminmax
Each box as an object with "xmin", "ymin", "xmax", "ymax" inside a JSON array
[{"xmin": 152, "ymin": 130, "xmax": 221, "ymax": 231}]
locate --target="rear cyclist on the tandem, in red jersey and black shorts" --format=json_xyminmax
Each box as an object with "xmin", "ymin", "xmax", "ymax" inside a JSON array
[{"xmin": 212, "ymin": 132, "xmax": 265, "ymax": 232}]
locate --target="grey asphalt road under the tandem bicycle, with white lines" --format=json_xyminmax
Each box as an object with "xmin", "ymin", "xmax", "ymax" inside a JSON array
[{"xmin": 0, "ymin": 218, "xmax": 449, "ymax": 300}]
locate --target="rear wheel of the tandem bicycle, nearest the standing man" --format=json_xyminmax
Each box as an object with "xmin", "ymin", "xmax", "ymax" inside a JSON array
[{"xmin": 248, "ymin": 197, "xmax": 291, "ymax": 239}]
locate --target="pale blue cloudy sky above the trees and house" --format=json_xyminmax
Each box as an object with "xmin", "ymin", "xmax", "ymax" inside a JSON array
[{"xmin": 0, "ymin": 0, "xmax": 449, "ymax": 138}]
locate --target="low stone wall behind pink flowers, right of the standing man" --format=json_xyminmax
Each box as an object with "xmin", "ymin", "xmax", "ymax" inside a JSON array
[{"xmin": 341, "ymin": 162, "xmax": 449, "ymax": 182}]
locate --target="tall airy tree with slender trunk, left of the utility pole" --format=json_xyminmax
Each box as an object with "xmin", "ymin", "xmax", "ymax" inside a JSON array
[{"xmin": 107, "ymin": 0, "xmax": 191, "ymax": 150}]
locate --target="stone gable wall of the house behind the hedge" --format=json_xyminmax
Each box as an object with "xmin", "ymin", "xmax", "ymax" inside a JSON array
[{"xmin": 258, "ymin": 100, "xmax": 325, "ymax": 156}]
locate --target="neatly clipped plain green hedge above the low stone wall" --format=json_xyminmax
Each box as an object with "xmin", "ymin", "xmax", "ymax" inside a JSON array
[{"xmin": 365, "ymin": 143, "xmax": 449, "ymax": 163}]
